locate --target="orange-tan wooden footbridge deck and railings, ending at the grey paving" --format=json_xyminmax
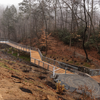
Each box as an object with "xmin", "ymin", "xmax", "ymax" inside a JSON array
[{"xmin": 0, "ymin": 39, "xmax": 71, "ymax": 76}]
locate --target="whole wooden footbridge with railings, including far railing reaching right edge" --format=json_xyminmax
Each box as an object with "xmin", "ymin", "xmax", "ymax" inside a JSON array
[{"xmin": 0, "ymin": 39, "xmax": 100, "ymax": 76}]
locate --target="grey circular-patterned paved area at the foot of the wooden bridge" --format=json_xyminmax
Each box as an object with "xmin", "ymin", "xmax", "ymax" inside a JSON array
[{"xmin": 57, "ymin": 74, "xmax": 100, "ymax": 98}]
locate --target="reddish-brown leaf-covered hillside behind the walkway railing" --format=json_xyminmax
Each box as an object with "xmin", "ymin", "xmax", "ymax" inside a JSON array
[{"xmin": 21, "ymin": 35, "xmax": 100, "ymax": 83}]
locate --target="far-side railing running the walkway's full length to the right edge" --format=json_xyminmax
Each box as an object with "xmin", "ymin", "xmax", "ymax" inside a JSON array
[{"xmin": 0, "ymin": 39, "xmax": 100, "ymax": 76}]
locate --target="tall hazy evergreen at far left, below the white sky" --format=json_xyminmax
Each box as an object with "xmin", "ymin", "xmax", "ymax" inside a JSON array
[{"xmin": 2, "ymin": 5, "xmax": 17, "ymax": 39}]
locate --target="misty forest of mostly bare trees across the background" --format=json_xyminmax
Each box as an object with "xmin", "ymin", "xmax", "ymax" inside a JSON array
[{"xmin": 0, "ymin": 0, "xmax": 100, "ymax": 60}]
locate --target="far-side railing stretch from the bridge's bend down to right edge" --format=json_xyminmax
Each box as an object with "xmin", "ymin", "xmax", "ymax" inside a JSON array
[{"xmin": 42, "ymin": 56, "xmax": 100, "ymax": 76}]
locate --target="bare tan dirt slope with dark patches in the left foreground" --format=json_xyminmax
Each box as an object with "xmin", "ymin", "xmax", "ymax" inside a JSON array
[{"xmin": 0, "ymin": 52, "xmax": 74, "ymax": 100}]
